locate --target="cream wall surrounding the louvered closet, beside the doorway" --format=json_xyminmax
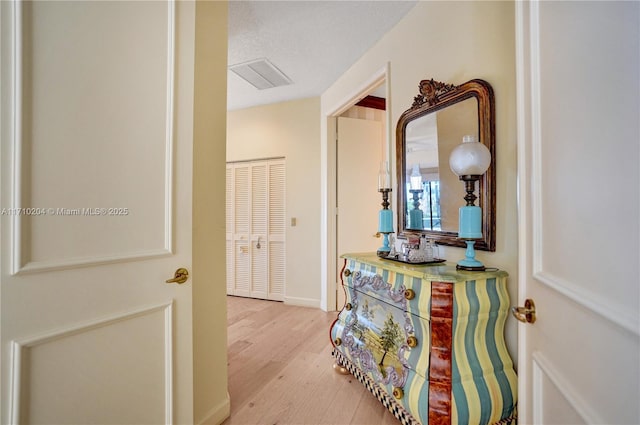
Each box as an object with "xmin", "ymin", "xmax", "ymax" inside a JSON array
[{"xmin": 227, "ymin": 97, "xmax": 320, "ymax": 307}]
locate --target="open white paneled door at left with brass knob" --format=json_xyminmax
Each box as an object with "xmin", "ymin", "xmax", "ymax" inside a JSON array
[{"xmin": 0, "ymin": 2, "xmax": 193, "ymax": 424}]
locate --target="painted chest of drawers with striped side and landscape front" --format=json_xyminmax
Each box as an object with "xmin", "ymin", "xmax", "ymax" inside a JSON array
[{"xmin": 330, "ymin": 253, "xmax": 517, "ymax": 425}]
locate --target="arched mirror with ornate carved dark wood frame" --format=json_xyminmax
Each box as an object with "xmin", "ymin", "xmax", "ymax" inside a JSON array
[{"xmin": 396, "ymin": 79, "xmax": 495, "ymax": 251}]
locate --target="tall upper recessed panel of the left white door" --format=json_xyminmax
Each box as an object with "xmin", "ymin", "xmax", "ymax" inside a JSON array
[{"xmin": 12, "ymin": 2, "xmax": 173, "ymax": 271}]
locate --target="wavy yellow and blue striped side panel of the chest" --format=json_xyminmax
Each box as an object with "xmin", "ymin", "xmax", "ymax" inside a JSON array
[{"xmin": 451, "ymin": 278, "xmax": 518, "ymax": 423}]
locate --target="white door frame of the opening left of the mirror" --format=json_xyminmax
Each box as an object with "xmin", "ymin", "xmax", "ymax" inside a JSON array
[{"xmin": 320, "ymin": 62, "xmax": 395, "ymax": 311}]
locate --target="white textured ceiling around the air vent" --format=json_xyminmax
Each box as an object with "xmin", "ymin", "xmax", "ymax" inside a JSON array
[{"xmin": 227, "ymin": 0, "xmax": 416, "ymax": 110}]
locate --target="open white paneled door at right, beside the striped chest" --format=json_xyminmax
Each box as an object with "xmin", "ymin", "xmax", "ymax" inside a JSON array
[{"xmin": 516, "ymin": 2, "xmax": 640, "ymax": 424}]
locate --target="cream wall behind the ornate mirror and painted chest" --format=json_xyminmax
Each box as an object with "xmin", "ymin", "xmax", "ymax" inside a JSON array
[{"xmin": 321, "ymin": 1, "xmax": 518, "ymax": 359}]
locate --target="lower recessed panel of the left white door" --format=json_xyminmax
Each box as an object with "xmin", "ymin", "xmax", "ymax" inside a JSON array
[{"xmin": 12, "ymin": 304, "xmax": 173, "ymax": 424}]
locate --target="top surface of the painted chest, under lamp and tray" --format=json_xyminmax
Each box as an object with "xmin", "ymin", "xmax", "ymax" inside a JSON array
[{"xmin": 340, "ymin": 252, "xmax": 508, "ymax": 282}]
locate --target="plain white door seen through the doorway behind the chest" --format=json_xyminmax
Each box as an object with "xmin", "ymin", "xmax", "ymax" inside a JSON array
[{"xmin": 336, "ymin": 117, "xmax": 382, "ymax": 309}]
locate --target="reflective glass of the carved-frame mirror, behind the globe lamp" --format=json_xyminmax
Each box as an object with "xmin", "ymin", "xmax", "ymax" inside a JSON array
[{"xmin": 405, "ymin": 98, "xmax": 479, "ymax": 232}]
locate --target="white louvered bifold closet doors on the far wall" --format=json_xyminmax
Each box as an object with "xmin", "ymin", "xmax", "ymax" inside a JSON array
[{"xmin": 226, "ymin": 159, "xmax": 285, "ymax": 301}]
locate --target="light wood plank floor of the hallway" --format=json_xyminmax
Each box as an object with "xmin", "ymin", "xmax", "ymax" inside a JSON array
[{"xmin": 223, "ymin": 297, "xmax": 399, "ymax": 425}]
